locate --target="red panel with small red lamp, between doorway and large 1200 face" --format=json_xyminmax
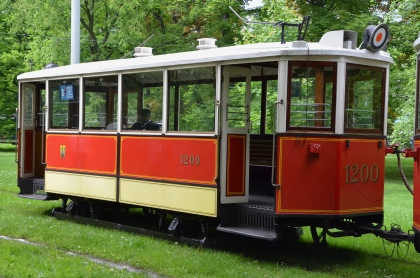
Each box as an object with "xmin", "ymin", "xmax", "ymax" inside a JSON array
[{"xmin": 276, "ymin": 136, "xmax": 337, "ymax": 216}]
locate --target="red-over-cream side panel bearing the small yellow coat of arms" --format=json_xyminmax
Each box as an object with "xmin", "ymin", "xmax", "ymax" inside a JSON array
[{"xmin": 45, "ymin": 134, "xmax": 117, "ymax": 202}]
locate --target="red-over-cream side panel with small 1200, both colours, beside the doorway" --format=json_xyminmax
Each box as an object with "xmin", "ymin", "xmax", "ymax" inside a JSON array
[{"xmin": 119, "ymin": 136, "xmax": 218, "ymax": 217}]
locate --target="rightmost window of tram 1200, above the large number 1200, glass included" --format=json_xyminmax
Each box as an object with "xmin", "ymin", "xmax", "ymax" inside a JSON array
[{"xmin": 345, "ymin": 65, "xmax": 385, "ymax": 133}]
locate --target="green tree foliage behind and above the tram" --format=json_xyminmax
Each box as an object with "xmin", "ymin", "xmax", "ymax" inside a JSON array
[{"xmin": 0, "ymin": 0, "xmax": 420, "ymax": 145}]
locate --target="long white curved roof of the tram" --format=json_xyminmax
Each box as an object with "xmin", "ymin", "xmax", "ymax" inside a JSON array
[{"xmin": 17, "ymin": 35, "xmax": 393, "ymax": 80}]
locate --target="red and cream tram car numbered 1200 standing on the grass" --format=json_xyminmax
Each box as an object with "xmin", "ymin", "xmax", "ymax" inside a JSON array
[{"xmin": 17, "ymin": 22, "xmax": 406, "ymax": 240}]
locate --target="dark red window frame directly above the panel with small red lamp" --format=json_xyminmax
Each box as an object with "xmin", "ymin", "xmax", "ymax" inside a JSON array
[{"xmin": 286, "ymin": 61, "xmax": 337, "ymax": 132}]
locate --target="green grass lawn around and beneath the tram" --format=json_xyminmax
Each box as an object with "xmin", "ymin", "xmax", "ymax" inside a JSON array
[{"xmin": 0, "ymin": 146, "xmax": 420, "ymax": 277}]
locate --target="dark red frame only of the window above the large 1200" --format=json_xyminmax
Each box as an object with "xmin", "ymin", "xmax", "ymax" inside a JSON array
[{"xmin": 344, "ymin": 64, "xmax": 386, "ymax": 134}]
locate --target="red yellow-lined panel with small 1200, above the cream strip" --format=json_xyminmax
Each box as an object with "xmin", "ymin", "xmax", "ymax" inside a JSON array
[{"xmin": 120, "ymin": 136, "xmax": 218, "ymax": 187}]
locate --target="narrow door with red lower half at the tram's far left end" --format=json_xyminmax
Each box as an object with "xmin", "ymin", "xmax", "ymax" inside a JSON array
[{"xmin": 19, "ymin": 83, "xmax": 35, "ymax": 178}]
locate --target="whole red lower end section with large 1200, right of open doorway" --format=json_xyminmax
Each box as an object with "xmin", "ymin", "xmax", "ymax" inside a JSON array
[{"xmin": 276, "ymin": 136, "xmax": 385, "ymax": 218}]
